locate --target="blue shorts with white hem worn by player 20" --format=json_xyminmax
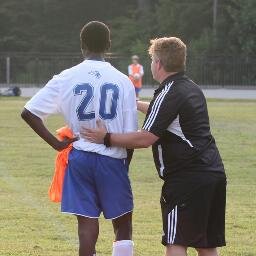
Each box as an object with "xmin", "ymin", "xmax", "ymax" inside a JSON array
[{"xmin": 61, "ymin": 148, "xmax": 133, "ymax": 219}]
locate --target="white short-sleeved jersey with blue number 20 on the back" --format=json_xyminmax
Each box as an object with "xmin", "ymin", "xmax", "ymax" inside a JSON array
[{"xmin": 25, "ymin": 60, "xmax": 138, "ymax": 158}]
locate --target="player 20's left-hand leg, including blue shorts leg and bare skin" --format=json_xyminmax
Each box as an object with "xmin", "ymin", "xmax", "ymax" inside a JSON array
[{"xmin": 61, "ymin": 149, "xmax": 101, "ymax": 256}]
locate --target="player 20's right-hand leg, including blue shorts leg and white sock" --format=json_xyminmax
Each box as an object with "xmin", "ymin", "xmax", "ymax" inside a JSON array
[{"xmin": 95, "ymin": 156, "xmax": 133, "ymax": 256}]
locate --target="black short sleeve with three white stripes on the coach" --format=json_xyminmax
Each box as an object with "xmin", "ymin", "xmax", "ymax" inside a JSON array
[{"xmin": 142, "ymin": 84, "xmax": 183, "ymax": 137}]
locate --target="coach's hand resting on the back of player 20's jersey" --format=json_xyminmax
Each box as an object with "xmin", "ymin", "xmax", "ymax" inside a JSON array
[{"xmin": 80, "ymin": 120, "xmax": 107, "ymax": 144}]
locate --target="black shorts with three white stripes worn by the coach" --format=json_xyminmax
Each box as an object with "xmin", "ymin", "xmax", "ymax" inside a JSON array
[{"xmin": 161, "ymin": 172, "xmax": 226, "ymax": 248}]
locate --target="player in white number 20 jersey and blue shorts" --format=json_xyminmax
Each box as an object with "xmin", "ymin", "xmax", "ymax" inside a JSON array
[{"xmin": 21, "ymin": 21, "xmax": 137, "ymax": 256}]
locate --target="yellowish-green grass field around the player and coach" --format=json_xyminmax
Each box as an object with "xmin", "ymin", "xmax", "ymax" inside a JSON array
[{"xmin": 0, "ymin": 98, "xmax": 256, "ymax": 256}]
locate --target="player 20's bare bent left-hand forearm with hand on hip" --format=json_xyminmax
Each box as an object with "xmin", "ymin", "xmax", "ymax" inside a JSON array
[{"xmin": 21, "ymin": 108, "xmax": 77, "ymax": 151}]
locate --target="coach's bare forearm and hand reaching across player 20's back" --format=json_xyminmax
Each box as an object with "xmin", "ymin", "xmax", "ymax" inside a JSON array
[{"xmin": 80, "ymin": 121, "xmax": 159, "ymax": 148}]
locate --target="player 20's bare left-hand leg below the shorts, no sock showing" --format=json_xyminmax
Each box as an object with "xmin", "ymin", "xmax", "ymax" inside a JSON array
[{"xmin": 77, "ymin": 216, "xmax": 99, "ymax": 256}]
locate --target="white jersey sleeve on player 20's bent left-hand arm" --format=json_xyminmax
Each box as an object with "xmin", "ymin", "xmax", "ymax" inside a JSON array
[{"xmin": 25, "ymin": 76, "xmax": 60, "ymax": 120}]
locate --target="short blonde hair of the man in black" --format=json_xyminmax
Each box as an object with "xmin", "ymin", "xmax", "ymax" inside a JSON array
[{"xmin": 148, "ymin": 37, "xmax": 187, "ymax": 72}]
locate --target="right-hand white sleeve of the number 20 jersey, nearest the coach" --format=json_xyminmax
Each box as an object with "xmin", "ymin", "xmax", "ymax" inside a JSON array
[{"xmin": 123, "ymin": 78, "xmax": 138, "ymax": 133}]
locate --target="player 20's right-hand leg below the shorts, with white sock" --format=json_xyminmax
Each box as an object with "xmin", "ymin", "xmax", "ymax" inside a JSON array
[{"xmin": 112, "ymin": 212, "xmax": 133, "ymax": 256}]
